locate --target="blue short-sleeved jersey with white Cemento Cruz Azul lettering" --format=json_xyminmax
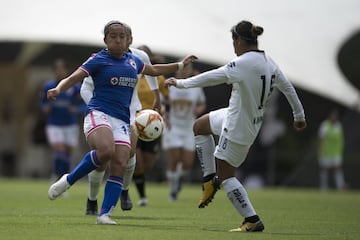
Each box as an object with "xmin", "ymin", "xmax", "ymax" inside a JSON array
[{"xmin": 81, "ymin": 49, "xmax": 144, "ymax": 123}]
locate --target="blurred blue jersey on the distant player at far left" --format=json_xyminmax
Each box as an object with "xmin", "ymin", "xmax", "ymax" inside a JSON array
[{"xmin": 40, "ymin": 80, "xmax": 85, "ymax": 126}]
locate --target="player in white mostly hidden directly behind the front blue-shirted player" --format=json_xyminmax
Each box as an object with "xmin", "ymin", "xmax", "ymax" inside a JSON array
[{"xmin": 80, "ymin": 24, "xmax": 161, "ymax": 215}]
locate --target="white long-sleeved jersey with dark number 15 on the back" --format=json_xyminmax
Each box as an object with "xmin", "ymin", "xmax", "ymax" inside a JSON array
[{"xmin": 177, "ymin": 51, "xmax": 305, "ymax": 145}]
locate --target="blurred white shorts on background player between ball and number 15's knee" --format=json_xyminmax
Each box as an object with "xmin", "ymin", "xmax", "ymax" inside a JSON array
[{"xmin": 161, "ymin": 124, "xmax": 195, "ymax": 151}]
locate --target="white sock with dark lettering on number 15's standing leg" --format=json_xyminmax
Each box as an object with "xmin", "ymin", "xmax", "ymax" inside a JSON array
[{"xmin": 221, "ymin": 177, "xmax": 256, "ymax": 218}]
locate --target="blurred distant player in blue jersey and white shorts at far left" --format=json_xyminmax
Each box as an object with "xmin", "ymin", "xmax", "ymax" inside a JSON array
[{"xmin": 40, "ymin": 59, "xmax": 86, "ymax": 183}]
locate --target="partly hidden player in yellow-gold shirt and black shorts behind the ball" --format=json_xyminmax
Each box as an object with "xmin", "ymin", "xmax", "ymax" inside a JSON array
[{"xmin": 133, "ymin": 45, "xmax": 169, "ymax": 206}]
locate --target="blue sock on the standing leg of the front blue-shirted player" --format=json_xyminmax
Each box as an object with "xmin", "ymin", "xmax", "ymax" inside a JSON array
[{"xmin": 99, "ymin": 176, "xmax": 123, "ymax": 216}]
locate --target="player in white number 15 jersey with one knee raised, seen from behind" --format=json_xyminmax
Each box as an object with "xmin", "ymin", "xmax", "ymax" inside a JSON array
[{"xmin": 165, "ymin": 21, "xmax": 306, "ymax": 232}]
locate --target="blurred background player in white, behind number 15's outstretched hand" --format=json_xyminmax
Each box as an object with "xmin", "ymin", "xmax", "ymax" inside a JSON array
[{"xmin": 162, "ymin": 61, "xmax": 206, "ymax": 201}]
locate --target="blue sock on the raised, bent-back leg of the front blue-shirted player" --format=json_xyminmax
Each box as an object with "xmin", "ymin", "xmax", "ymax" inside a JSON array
[{"xmin": 67, "ymin": 150, "xmax": 100, "ymax": 185}]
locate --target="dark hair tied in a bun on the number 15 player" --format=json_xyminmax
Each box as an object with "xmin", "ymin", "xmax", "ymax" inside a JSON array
[{"xmin": 231, "ymin": 20, "xmax": 264, "ymax": 44}]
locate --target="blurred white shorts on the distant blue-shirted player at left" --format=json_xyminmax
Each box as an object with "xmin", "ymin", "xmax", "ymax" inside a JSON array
[{"xmin": 45, "ymin": 124, "xmax": 79, "ymax": 147}]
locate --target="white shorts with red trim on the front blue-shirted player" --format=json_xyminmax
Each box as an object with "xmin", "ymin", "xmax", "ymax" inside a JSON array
[{"xmin": 84, "ymin": 110, "xmax": 130, "ymax": 147}]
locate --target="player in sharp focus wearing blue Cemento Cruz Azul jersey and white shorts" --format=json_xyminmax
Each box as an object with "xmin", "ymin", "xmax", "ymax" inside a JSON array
[{"xmin": 47, "ymin": 21, "xmax": 196, "ymax": 224}]
